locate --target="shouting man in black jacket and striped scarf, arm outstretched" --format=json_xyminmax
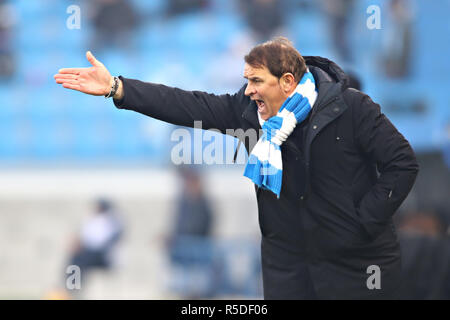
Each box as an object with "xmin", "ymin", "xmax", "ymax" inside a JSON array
[{"xmin": 55, "ymin": 38, "xmax": 418, "ymax": 299}]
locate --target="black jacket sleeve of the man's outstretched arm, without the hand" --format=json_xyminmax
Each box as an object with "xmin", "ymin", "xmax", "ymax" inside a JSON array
[{"xmin": 110, "ymin": 76, "xmax": 250, "ymax": 133}]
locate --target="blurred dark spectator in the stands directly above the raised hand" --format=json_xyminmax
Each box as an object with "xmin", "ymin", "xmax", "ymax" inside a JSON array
[{"xmin": 89, "ymin": 0, "xmax": 139, "ymax": 52}]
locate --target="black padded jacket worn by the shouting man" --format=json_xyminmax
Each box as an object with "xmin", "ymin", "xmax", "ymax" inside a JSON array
[{"xmin": 115, "ymin": 57, "xmax": 418, "ymax": 299}]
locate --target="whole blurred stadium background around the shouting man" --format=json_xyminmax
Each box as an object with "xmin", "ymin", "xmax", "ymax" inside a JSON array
[{"xmin": 0, "ymin": 0, "xmax": 450, "ymax": 299}]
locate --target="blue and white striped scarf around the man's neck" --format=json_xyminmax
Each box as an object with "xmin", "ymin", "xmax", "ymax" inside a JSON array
[{"xmin": 244, "ymin": 69, "xmax": 317, "ymax": 198}]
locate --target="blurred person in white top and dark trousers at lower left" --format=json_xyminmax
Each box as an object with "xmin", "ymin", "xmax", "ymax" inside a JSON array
[{"xmin": 69, "ymin": 199, "xmax": 123, "ymax": 294}]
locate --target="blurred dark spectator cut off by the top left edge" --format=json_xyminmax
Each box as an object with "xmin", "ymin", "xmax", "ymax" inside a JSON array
[{"xmin": 0, "ymin": 0, "xmax": 16, "ymax": 80}]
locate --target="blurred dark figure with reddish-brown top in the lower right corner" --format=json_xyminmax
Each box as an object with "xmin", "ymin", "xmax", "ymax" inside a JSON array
[{"xmin": 399, "ymin": 211, "xmax": 450, "ymax": 300}]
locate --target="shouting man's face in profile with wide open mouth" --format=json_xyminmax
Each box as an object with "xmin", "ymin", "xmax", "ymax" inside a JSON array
[{"xmin": 244, "ymin": 63, "xmax": 288, "ymax": 120}]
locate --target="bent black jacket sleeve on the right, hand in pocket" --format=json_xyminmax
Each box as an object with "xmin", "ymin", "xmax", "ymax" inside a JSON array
[{"xmin": 353, "ymin": 95, "xmax": 419, "ymax": 237}]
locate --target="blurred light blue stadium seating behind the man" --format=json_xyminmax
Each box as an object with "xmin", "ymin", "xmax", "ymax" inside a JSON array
[{"xmin": 0, "ymin": 0, "xmax": 450, "ymax": 162}]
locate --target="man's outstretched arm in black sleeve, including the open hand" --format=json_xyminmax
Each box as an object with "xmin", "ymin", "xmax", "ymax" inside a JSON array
[{"xmin": 55, "ymin": 51, "xmax": 250, "ymax": 133}]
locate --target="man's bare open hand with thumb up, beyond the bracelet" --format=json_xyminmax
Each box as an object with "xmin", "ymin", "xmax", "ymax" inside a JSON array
[{"xmin": 54, "ymin": 51, "xmax": 113, "ymax": 96}]
